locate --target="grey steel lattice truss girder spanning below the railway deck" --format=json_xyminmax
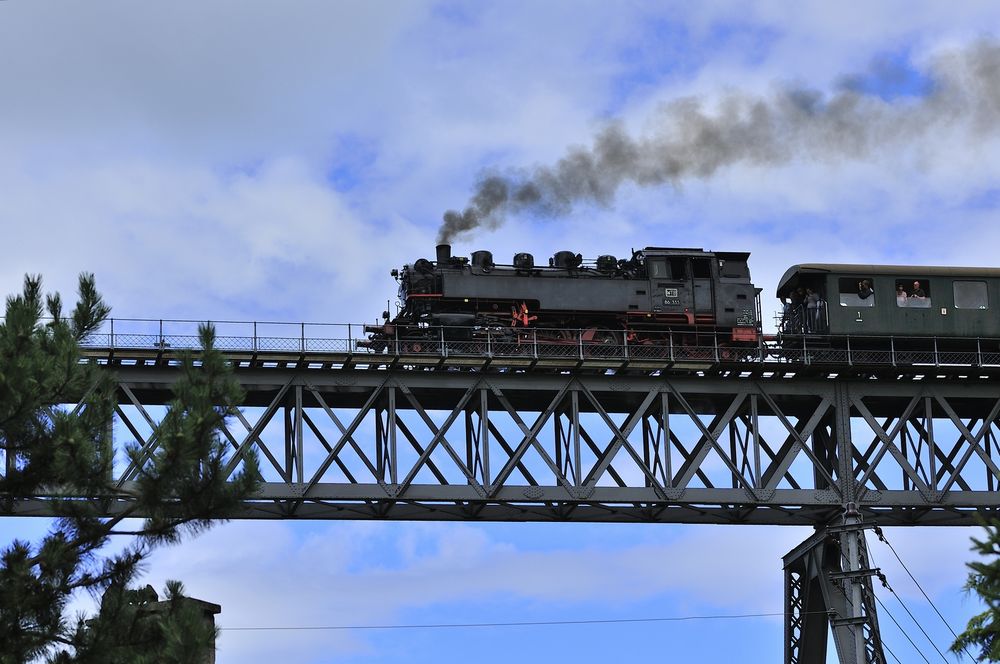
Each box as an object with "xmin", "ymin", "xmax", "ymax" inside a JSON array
[{"xmin": 12, "ymin": 362, "xmax": 1000, "ymax": 526}]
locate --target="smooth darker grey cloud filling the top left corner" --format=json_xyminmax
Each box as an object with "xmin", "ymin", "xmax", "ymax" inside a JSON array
[{"xmin": 0, "ymin": 0, "xmax": 424, "ymax": 159}]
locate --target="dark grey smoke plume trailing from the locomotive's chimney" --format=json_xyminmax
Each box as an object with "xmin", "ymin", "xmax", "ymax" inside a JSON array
[{"xmin": 438, "ymin": 39, "xmax": 1000, "ymax": 243}]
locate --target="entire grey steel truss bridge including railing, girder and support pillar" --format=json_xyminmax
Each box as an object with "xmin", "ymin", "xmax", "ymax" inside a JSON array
[{"xmin": 13, "ymin": 320, "xmax": 1000, "ymax": 664}]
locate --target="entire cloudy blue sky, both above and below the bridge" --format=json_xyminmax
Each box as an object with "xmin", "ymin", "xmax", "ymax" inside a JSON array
[{"xmin": 0, "ymin": 0, "xmax": 1000, "ymax": 663}]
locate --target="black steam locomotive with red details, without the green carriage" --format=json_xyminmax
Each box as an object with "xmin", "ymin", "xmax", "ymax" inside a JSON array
[{"xmin": 366, "ymin": 244, "xmax": 761, "ymax": 351}]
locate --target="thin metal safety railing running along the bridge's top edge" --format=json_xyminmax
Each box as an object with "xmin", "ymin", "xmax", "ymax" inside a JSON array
[{"xmin": 74, "ymin": 318, "xmax": 1000, "ymax": 369}]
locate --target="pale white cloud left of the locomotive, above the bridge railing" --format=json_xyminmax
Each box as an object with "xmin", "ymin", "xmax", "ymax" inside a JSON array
[{"xmin": 0, "ymin": 159, "xmax": 410, "ymax": 320}]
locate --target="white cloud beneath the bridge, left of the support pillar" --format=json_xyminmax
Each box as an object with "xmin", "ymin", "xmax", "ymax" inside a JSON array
[{"xmin": 135, "ymin": 522, "xmax": 808, "ymax": 662}]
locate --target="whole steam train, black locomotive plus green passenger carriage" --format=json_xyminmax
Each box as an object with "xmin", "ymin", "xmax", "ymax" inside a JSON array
[{"xmin": 362, "ymin": 244, "xmax": 1000, "ymax": 361}]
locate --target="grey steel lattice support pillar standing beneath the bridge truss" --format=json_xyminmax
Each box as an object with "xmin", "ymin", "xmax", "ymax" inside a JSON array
[{"xmin": 783, "ymin": 504, "xmax": 885, "ymax": 664}]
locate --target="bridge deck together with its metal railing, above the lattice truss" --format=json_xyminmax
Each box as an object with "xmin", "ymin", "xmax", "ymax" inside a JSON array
[{"xmin": 84, "ymin": 319, "xmax": 1000, "ymax": 379}]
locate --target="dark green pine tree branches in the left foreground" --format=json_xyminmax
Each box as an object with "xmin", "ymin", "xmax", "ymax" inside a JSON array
[{"xmin": 0, "ymin": 275, "xmax": 260, "ymax": 662}]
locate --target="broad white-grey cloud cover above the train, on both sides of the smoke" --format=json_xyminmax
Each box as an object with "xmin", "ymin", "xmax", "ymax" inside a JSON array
[{"xmin": 7, "ymin": 1, "xmax": 1000, "ymax": 320}]
